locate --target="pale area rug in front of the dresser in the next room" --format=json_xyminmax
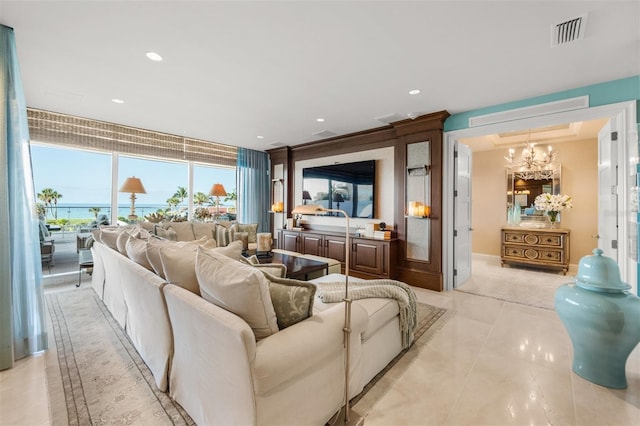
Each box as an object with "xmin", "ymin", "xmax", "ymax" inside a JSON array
[{"xmin": 456, "ymin": 256, "xmax": 573, "ymax": 310}]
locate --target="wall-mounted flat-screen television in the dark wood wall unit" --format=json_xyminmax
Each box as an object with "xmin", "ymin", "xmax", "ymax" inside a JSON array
[{"xmin": 302, "ymin": 160, "xmax": 376, "ymax": 218}]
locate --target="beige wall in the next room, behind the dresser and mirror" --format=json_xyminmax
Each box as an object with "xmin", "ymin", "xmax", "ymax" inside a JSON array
[{"xmin": 471, "ymin": 139, "xmax": 598, "ymax": 264}]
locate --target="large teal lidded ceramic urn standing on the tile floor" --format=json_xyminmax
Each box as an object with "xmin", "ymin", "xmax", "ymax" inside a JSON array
[{"xmin": 555, "ymin": 249, "xmax": 640, "ymax": 389}]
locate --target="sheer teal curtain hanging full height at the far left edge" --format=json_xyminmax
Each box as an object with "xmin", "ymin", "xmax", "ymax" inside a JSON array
[{"xmin": 0, "ymin": 25, "xmax": 47, "ymax": 370}]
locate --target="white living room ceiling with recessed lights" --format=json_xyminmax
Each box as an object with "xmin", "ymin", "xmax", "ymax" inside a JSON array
[{"xmin": 0, "ymin": 0, "xmax": 640, "ymax": 150}]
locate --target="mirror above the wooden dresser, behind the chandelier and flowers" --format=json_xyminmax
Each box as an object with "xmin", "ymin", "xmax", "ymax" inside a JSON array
[{"xmin": 506, "ymin": 163, "xmax": 561, "ymax": 217}]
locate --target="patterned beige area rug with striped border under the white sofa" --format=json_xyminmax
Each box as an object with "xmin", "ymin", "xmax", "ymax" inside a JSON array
[{"xmin": 46, "ymin": 288, "xmax": 447, "ymax": 425}]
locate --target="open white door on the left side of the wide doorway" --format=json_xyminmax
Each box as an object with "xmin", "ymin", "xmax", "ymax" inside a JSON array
[{"xmin": 453, "ymin": 142, "xmax": 471, "ymax": 288}]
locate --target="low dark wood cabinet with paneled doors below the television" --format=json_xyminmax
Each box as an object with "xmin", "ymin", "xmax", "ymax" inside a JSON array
[{"xmin": 279, "ymin": 230, "xmax": 397, "ymax": 279}]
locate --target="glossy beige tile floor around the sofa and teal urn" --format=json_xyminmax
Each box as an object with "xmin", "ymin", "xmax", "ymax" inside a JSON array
[{"xmin": 0, "ymin": 262, "xmax": 640, "ymax": 426}]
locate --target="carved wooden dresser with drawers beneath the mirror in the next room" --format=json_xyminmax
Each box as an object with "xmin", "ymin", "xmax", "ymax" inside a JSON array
[{"xmin": 500, "ymin": 226, "xmax": 569, "ymax": 275}]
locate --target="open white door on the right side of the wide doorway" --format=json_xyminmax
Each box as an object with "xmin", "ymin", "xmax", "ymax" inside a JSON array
[{"xmin": 597, "ymin": 120, "xmax": 619, "ymax": 262}]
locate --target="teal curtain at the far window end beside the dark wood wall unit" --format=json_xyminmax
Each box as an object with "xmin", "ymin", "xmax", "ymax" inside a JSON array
[{"xmin": 237, "ymin": 148, "xmax": 271, "ymax": 232}]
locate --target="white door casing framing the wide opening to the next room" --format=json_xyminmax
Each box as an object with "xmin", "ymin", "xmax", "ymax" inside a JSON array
[{"xmin": 443, "ymin": 101, "xmax": 637, "ymax": 292}]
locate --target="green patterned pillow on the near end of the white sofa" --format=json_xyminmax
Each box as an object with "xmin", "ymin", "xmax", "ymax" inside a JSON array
[{"xmin": 264, "ymin": 273, "xmax": 316, "ymax": 330}]
